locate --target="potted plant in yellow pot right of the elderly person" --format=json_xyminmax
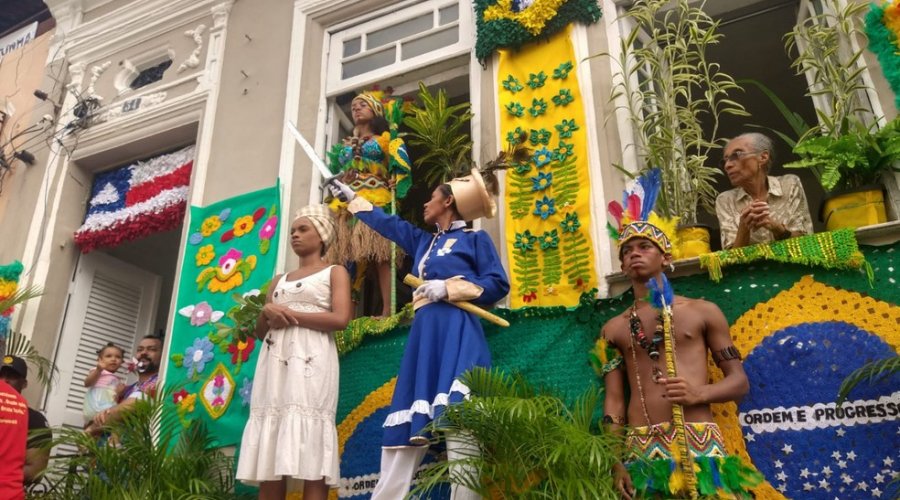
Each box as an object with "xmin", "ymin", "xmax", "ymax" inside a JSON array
[{"xmin": 785, "ymin": 0, "xmax": 900, "ymax": 230}]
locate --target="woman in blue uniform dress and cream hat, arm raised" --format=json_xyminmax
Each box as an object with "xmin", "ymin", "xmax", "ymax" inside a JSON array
[{"xmin": 335, "ymin": 169, "xmax": 509, "ymax": 500}]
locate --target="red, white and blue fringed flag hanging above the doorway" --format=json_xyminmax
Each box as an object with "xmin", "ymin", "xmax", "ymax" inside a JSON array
[{"xmin": 75, "ymin": 146, "xmax": 194, "ymax": 253}]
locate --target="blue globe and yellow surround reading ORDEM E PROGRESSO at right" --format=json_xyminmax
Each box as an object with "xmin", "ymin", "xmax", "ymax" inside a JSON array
[{"xmin": 709, "ymin": 276, "xmax": 900, "ymax": 499}]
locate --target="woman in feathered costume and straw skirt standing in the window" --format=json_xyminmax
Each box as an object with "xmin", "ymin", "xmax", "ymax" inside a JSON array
[{"xmin": 328, "ymin": 91, "xmax": 412, "ymax": 317}]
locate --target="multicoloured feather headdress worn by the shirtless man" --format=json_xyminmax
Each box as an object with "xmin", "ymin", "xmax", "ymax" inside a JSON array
[{"xmin": 606, "ymin": 168, "xmax": 678, "ymax": 258}]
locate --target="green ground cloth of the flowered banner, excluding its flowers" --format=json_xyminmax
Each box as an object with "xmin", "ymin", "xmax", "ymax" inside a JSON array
[{"xmin": 165, "ymin": 185, "xmax": 281, "ymax": 446}]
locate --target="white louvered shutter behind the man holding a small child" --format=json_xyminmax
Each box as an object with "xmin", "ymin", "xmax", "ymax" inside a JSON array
[{"xmin": 46, "ymin": 252, "xmax": 160, "ymax": 427}]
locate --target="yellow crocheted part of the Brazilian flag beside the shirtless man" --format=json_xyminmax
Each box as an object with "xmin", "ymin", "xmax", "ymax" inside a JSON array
[{"xmin": 708, "ymin": 276, "xmax": 900, "ymax": 500}]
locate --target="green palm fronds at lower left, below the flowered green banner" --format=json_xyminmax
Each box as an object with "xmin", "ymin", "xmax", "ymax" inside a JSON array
[{"xmin": 29, "ymin": 388, "xmax": 247, "ymax": 500}]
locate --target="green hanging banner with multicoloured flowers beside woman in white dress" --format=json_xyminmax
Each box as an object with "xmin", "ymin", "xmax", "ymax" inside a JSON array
[{"xmin": 165, "ymin": 185, "xmax": 281, "ymax": 446}]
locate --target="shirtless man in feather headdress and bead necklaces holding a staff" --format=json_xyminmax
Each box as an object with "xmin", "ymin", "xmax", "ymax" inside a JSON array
[{"xmin": 591, "ymin": 170, "xmax": 762, "ymax": 499}]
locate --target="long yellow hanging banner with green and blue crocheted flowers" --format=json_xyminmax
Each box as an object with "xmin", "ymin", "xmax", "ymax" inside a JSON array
[{"xmin": 498, "ymin": 28, "xmax": 597, "ymax": 308}]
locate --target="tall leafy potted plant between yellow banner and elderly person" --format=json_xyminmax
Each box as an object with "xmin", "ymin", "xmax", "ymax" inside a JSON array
[{"xmin": 612, "ymin": 0, "xmax": 749, "ymax": 257}]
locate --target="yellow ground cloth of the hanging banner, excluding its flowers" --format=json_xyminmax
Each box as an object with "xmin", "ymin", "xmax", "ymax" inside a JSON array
[{"xmin": 496, "ymin": 27, "xmax": 597, "ymax": 308}]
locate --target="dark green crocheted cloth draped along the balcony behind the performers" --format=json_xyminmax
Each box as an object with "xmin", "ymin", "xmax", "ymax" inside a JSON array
[{"xmin": 337, "ymin": 243, "xmax": 900, "ymax": 422}]
